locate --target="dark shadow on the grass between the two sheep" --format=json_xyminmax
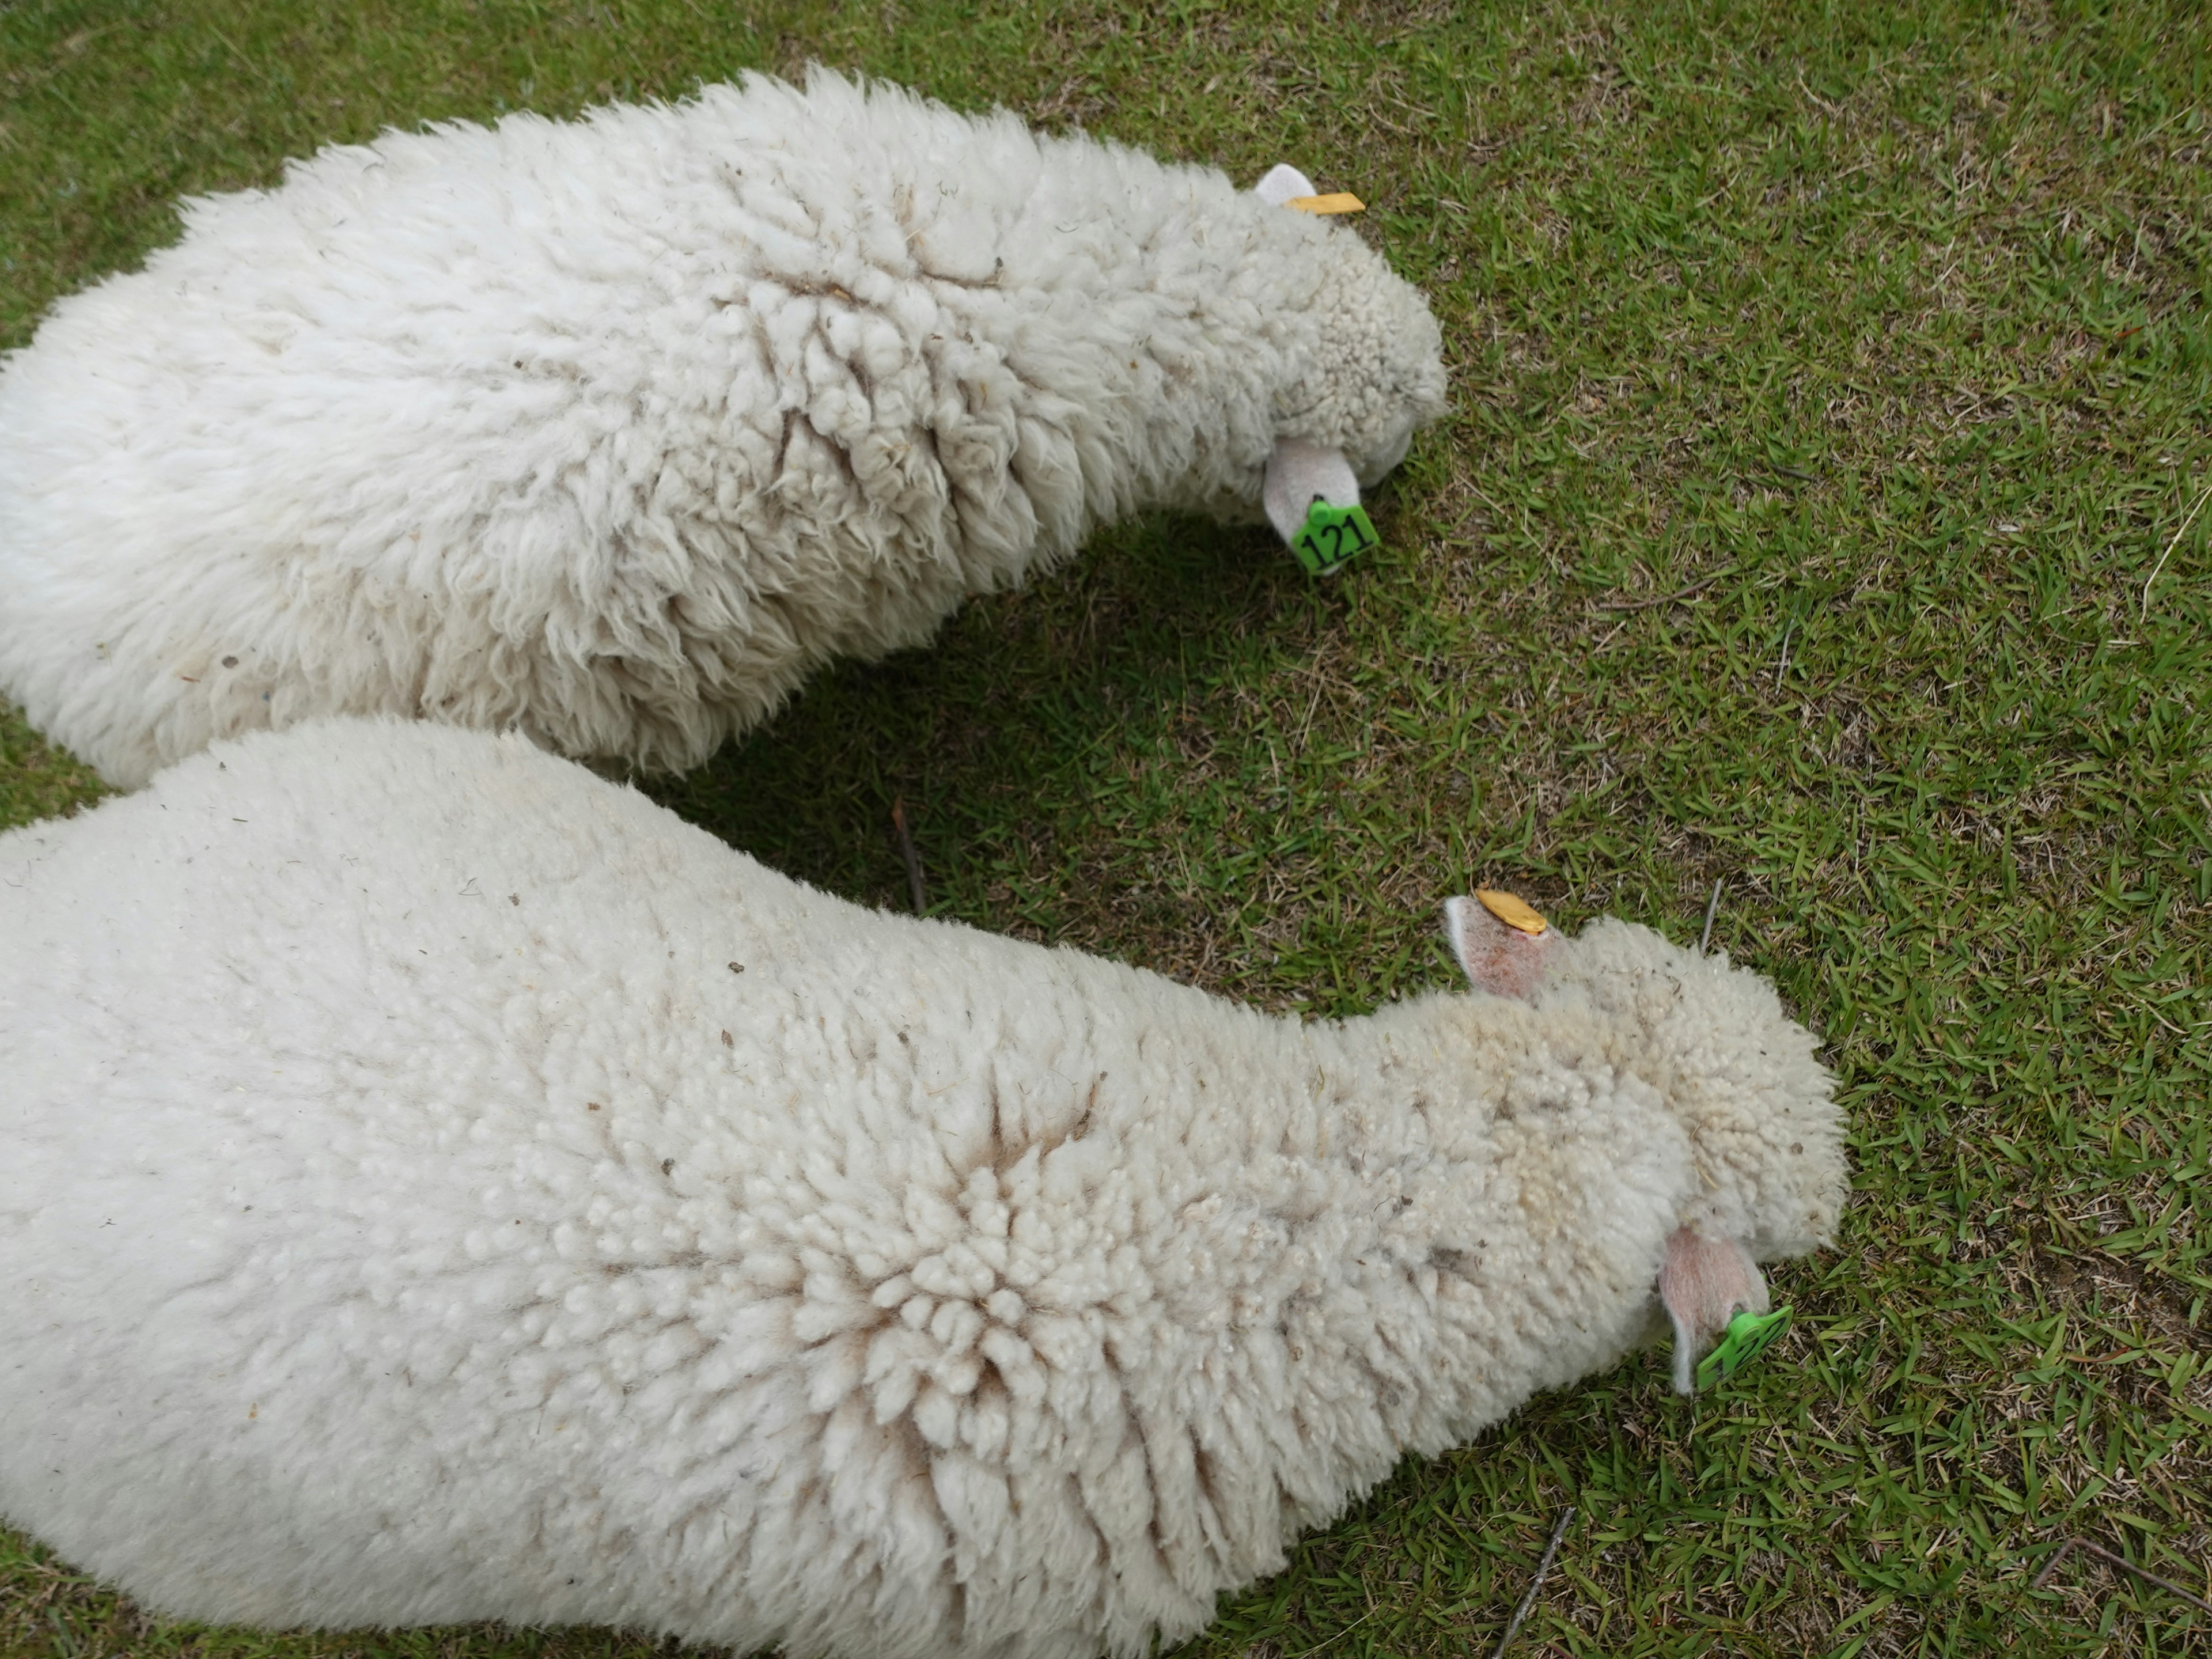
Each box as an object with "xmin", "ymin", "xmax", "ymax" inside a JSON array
[{"xmin": 637, "ymin": 520, "xmax": 1358, "ymax": 916}]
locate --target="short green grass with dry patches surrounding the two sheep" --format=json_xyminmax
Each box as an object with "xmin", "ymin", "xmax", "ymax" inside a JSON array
[{"xmin": 0, "ymin": 0, "xmax": 2212, "ymax": 1659}]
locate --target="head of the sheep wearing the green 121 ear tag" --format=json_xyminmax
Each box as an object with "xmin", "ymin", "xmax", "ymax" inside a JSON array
[{"xmin": 1254, "ymin": 166, "xmax": 1445, "ymax": 540}]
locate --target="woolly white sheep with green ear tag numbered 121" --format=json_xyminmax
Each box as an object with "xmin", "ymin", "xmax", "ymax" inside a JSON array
[{"xmin": 0, "ymin": 73, "xmax": 1445, "ymax": 787}]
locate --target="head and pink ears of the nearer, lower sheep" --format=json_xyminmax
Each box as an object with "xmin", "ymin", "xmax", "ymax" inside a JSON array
[{"xmin": 1445, "ymin": 898, "xmax": 1849, "ymax": 1393}]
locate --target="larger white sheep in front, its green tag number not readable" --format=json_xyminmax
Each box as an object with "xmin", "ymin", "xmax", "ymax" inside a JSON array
[{"xmin": 0, "ymin": 721, "xmax": 1845, "ymax": 1659}]
